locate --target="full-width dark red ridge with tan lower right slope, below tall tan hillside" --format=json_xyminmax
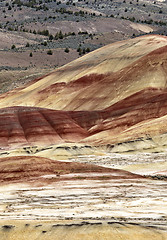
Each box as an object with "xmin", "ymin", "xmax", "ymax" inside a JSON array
[{"xmin": 0, "ymin": 85, "xmax": 167, "ymax": 148}]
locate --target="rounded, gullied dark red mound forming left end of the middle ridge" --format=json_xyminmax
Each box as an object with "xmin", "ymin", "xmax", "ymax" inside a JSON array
[{"xmin": 0, "ymin": 107, "xmax": 88, "ymax": 148}]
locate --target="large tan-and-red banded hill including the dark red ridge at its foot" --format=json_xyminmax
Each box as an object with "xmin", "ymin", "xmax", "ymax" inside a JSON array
[{"xmin": 0, "ymin": 35, "xmax": 167, "ymax": 151}]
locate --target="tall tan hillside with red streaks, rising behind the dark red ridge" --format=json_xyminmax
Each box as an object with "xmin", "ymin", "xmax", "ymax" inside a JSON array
[{"xmin": 0, "ymin": 35, "xmax": 167, "ymax": 110}]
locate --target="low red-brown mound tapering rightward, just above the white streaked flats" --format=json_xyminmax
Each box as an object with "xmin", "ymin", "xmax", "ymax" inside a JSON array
[{"xmin": 0, "ymin": 156, "xmax": 143, "ymax": 182}]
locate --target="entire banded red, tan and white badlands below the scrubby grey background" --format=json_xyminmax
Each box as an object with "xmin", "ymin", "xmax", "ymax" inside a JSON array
[{"xmin": 0, "ymin": 35, "xmax": 167, "ymax": 240}]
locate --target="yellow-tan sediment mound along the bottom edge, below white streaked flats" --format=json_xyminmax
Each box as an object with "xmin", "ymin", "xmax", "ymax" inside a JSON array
[{"xmin": 0, "ymin": 221, "xmax": 167, "ymax": 240}]
